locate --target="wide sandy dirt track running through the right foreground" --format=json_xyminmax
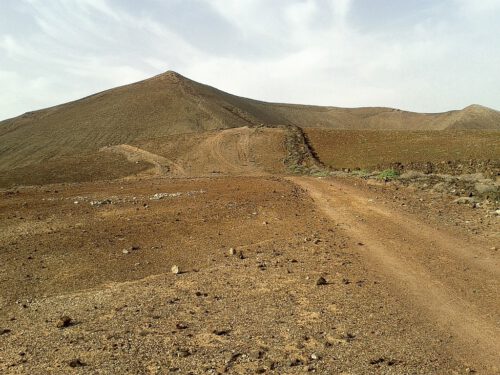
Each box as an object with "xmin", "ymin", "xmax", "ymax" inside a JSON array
[{"xmin": 292, "ymin": 177, "xmax": 500, "ymax": 373}]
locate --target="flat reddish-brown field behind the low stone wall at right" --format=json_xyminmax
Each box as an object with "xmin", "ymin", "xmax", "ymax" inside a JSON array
[{"xmin": 305, "ymin": 128, "xmax": 500, "ymax": 169}]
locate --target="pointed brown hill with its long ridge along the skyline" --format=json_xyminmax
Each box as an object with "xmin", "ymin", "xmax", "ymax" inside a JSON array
[{"xmin": 0, "ymin": 71, "xmax": 500, "ymax": 171}]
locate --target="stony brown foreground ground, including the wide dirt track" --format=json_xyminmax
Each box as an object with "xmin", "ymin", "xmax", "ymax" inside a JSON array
[{"xmin": 0, "ymin": 177, "xmax": 500, "ymax": 374}]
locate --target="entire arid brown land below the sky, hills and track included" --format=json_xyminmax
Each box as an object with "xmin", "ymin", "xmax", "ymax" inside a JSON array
[{"xmin": 0, "ymin": 72, "xmax": 500, "ymax": 374}]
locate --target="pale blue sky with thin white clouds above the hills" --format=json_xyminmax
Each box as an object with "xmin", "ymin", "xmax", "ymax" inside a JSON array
[{"xmin": 0, "ymin": 0, "xmax": 500, "ymax": 119}]
